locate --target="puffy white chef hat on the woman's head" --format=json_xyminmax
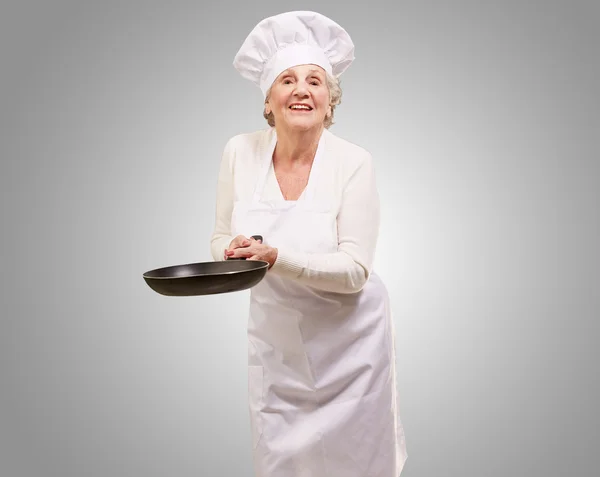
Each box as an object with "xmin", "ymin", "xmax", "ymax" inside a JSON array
[{"xmin": 233, "ymin": 11, "xmax": 354, "ymax": 95}]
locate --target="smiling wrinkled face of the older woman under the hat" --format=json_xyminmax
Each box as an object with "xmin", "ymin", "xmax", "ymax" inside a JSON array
[{"xmin": 265, "ymin": 65, "xmax": 331, "ymax": 130}]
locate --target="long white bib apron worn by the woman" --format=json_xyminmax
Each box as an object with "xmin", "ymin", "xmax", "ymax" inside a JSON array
[{"xmin": 232, "ymin": 131, "xmax": 407, "ymax": 477}]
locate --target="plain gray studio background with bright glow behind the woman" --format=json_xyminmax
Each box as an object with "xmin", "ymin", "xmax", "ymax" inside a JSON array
[{"xmin": 0, "ymin": 0, "xmax": 600, "ymax": 477}]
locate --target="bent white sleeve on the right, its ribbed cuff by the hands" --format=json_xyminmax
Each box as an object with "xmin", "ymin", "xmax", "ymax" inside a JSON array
[{"xmin": 270, "ymin": 154, "xmax": 380, "ymax": 293}]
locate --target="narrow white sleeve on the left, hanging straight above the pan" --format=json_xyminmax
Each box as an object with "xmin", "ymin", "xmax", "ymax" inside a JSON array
[{"xmin": 210, "ymin": 139, "xmax": 235, "ymax": 261}]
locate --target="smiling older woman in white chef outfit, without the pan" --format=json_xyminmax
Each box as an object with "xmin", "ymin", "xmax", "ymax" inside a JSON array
[{"xmin": 211, "ymin": 12, "xmax": 407, "ymax": 477}]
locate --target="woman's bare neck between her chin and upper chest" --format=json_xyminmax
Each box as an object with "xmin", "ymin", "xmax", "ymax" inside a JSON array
[{"xmin": 273, "ymin": 125, "xmax": 324, "ymax": 165}]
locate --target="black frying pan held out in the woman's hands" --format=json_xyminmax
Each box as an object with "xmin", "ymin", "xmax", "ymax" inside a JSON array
[{"xmin": 143, "ymin": 235, "xmax": 269, "ymax": 296}]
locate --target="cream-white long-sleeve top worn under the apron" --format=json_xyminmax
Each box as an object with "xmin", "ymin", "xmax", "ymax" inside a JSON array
[{"xmin": 211, "ymin": 128, "xmax": 380, "ymax": 293}]
